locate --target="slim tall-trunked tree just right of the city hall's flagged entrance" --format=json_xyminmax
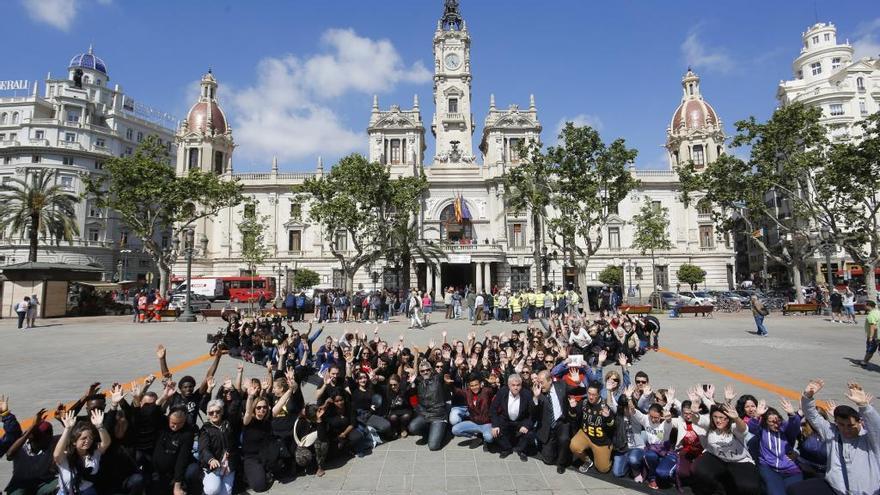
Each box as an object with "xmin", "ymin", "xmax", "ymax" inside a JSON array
[{"xmin": 502, "ymin": 140, "xmax": 553, "ymax": 288}]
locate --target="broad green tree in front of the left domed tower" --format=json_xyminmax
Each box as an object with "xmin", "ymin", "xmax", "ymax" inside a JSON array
[{"xmin": 84, "ymin": 136, "xmax": 242, "ymax": 294}]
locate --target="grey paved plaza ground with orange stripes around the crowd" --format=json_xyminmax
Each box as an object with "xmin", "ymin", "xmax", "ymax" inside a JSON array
[{"xmin": 0, "ymin": 313, "xmax": 880, "ymax": 495}]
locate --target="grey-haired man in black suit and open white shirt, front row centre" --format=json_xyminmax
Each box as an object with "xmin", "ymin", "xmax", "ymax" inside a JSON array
[{"xmin": 490, "ymin": 373, "xmax": 534, "ymax": 462}]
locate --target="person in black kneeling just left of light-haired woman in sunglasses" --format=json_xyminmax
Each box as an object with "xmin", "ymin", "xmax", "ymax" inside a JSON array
[{"xmin": 150, "ymin": 410, "xmax": 201, "ymax": 495}]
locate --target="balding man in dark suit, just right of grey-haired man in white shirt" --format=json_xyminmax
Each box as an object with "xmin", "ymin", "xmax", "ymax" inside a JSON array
[{"xmin": 532, "ymin": 370, "xmax": 571, "ymax": 474}]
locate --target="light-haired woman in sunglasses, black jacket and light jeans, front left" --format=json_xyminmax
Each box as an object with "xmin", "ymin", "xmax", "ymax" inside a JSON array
[{"xmin": 199, "ymin": 399, "xmax": 239, "ymax": 495}]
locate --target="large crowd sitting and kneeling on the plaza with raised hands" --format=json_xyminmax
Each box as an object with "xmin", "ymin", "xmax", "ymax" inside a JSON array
[{"xmin": 0, "ymin": 305, "xmax": 880, "ymax": 495}]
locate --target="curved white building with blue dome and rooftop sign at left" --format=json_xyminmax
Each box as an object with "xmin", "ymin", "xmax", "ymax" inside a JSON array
[{"xmin": 0, "ymin": 47, "xmax": 175, "ymax": 280}]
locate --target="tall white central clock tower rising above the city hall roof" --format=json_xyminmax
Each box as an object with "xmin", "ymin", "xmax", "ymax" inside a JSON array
[{"xmin": 431, "ymin": 0, "xmax": 475, "ymax": 164}]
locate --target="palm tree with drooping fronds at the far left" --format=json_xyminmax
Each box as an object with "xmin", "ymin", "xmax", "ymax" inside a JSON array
[{"xmin": 0, "ymin": 169, "xmax": 79, "ymax": 261}]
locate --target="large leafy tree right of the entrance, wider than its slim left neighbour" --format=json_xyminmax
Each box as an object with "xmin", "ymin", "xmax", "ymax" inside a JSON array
[{"xmin": 545, "ymin": 122, "xmax": 638, "ymax": 309}]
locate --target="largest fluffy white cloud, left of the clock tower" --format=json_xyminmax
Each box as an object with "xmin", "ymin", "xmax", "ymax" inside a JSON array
[{"xmin": 229, "ymin": 29, "xmax": 431, "ymax": 164}]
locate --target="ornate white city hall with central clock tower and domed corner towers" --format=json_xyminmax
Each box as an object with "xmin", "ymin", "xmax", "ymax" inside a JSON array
[{"xmin": 174, "ymin": 2, "xmax": 734, "ymax": 298}]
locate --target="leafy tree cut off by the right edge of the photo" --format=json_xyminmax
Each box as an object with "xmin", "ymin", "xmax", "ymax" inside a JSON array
[{"xmin": 816, "ymin": 112, "xmax": 880, "ymax": 301}]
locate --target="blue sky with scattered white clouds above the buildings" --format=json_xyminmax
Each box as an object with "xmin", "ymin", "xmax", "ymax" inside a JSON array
[{"xmin": 6, "ymin": 0, "xmax": 880, "ymax": 172}]
